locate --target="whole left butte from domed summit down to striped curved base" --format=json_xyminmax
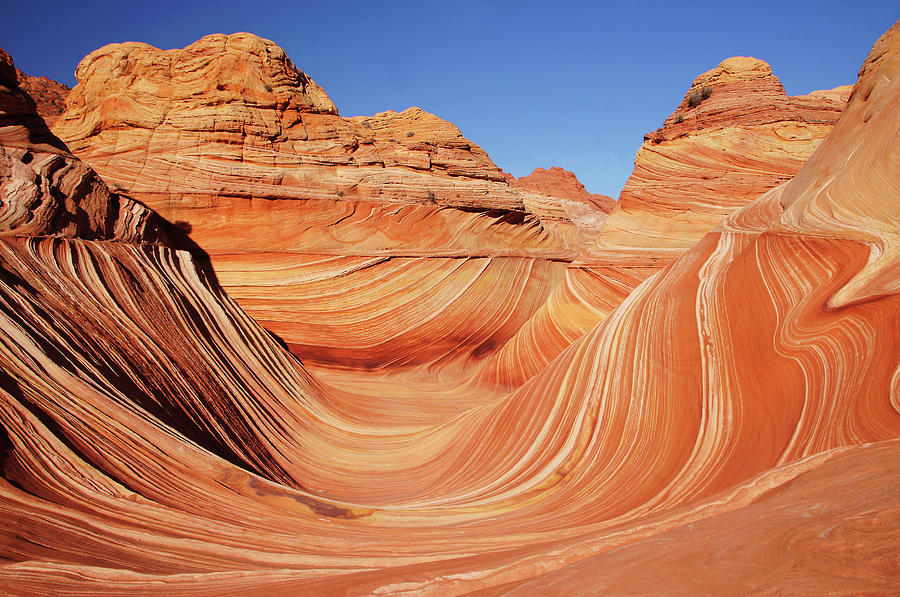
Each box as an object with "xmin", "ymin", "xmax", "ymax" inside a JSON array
[{"xmin": 54, "ymin": 34, "xmax": 620, "ymax": 367}]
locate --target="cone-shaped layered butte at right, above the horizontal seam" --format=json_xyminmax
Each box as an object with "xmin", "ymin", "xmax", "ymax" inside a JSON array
[{"xmin": 598, "ymin": 57, "xmax": 851, "ymax": 261}]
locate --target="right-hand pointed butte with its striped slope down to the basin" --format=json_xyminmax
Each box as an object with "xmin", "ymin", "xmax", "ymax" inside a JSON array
[{"xmin": 479, "ymin": 52, "xmax": 851, "ymax": 385}]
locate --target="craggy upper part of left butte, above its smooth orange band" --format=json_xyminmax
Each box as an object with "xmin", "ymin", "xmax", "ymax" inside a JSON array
[{"xmin": 55, "ymin": 34, "xmax": 557, "ymax": 233}]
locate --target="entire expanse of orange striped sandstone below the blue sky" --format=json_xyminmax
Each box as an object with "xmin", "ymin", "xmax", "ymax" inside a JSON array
[{"xmin": 0, "ymin": 25, "xmax": 900, "ymax": 595}]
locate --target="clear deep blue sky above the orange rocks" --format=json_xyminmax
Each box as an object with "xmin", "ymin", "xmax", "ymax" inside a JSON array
[{"xmin": 0, "ymin": 0, "xmax": 900, "ymax": 197}]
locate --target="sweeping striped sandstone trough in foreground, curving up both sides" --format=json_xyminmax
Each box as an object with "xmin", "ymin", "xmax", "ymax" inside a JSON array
[{"xmin": 0, "ymin": 24, "xmax": 900, "ymax": 595}]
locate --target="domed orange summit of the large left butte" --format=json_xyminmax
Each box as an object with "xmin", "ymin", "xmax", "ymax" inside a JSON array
[{"xmin": 62, "ymin": 33, "xmax": 337, "ymax": 144}]
